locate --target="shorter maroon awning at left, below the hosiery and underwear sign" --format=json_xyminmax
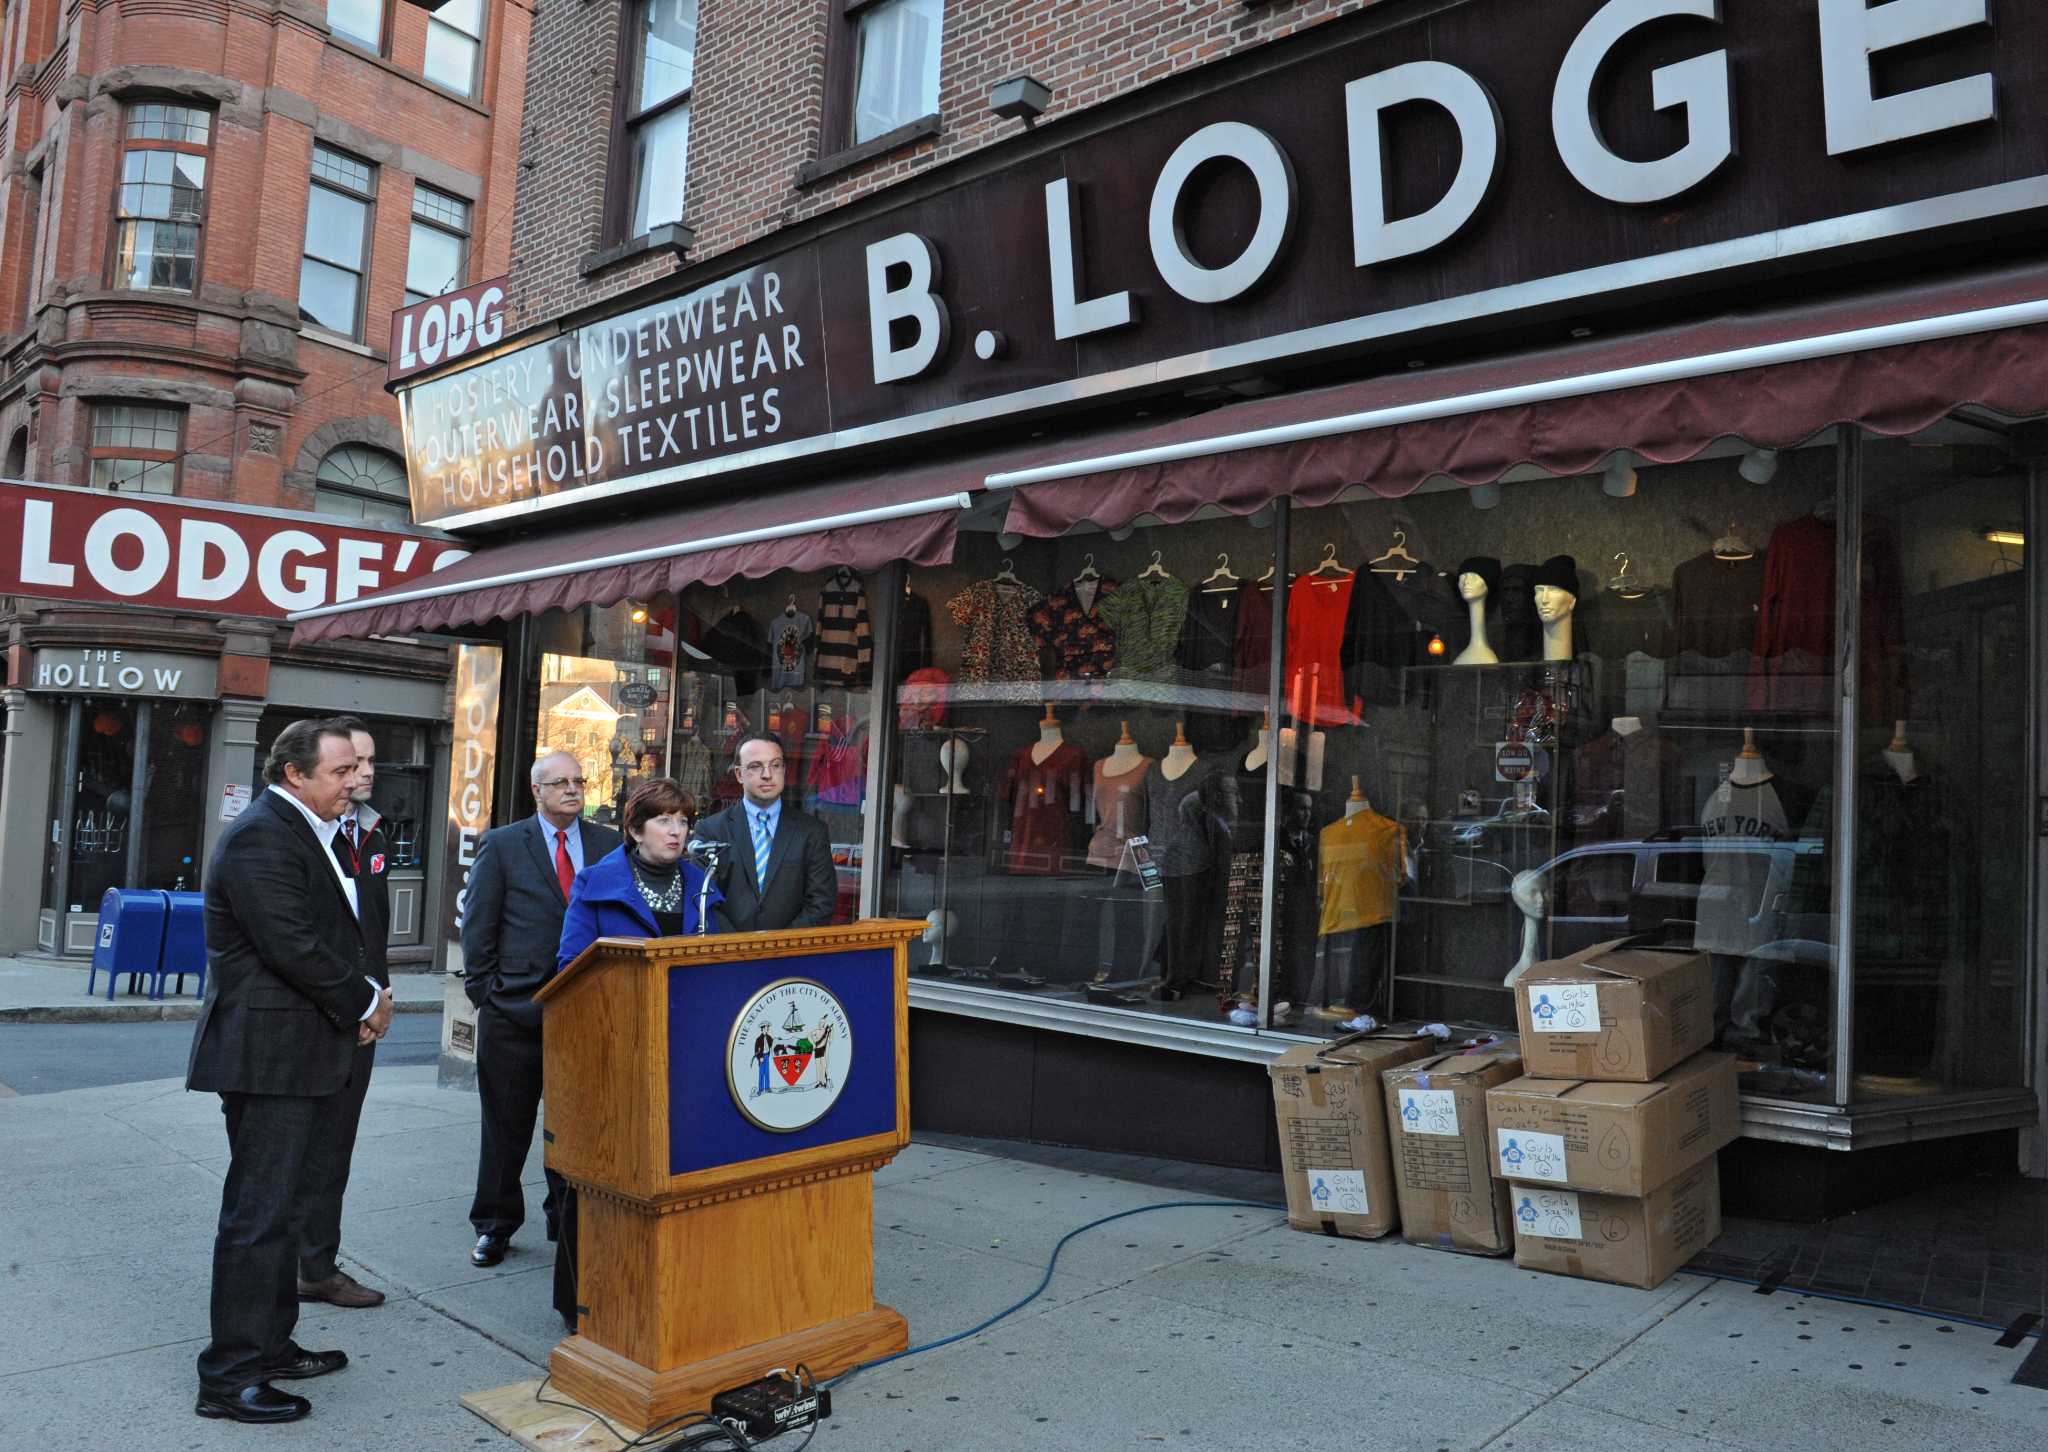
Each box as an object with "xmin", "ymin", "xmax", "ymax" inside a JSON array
[{"xmin": 291, "ymin": 451, "xmax": 987, "ymax": 645}]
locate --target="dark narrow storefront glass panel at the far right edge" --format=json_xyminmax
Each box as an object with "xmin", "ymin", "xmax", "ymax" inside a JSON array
[{"xmin": 1853, "ymin": 418, "xmax": 2030, "ymax": 1102}]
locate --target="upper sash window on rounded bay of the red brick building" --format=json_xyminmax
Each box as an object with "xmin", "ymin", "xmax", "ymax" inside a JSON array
[{"xmin": 115, "ymin": 100, "xmax": 213, "ymax": 293}]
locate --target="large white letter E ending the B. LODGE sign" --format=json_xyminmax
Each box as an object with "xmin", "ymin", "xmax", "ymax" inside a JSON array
[{"xmin": 1821, "ymin": 0, "xmax": 1997, "ymax": 156}]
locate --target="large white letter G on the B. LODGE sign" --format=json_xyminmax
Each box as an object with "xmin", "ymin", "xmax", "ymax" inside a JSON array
[{"xmin": 1550, "ymin": 0, "xmax": 1735, "ymax": 205}]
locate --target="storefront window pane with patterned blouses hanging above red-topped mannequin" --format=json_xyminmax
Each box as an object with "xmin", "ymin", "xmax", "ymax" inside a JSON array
[{"xmin": 885, "ymin": 518, "xmax": 1284, "ymax": 1026}]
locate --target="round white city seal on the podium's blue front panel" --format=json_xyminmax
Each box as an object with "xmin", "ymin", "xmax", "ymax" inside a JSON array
[{"xmin": 725, "ymin": 979, "xmax": 854, "ymax": 1135}]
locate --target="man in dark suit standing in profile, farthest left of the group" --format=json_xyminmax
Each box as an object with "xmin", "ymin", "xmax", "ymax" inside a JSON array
[{"xmin": 184, "ymin": 721, "xmax": 391, "ymax": 1421}]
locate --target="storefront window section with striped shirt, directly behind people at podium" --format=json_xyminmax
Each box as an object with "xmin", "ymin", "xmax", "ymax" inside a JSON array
[{"xmin": 670, "ymin": 569, "xmax": 877, "ymax": 922}]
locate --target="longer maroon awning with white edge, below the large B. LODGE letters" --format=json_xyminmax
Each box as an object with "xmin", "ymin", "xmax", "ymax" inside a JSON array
[{"xmin": 987, "ymin": 264, "xmax": 2048, "ymax": 537}]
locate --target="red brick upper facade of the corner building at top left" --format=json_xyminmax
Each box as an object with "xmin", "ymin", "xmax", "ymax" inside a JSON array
[{"xmin": 0, "ymin": 0, "xmax": 528, "ymax": 508}]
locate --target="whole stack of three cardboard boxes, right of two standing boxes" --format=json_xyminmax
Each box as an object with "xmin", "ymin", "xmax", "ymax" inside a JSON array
[{"xmin": 1487, "ymin": 942, "xmax": 1739, "ymax": 1288}]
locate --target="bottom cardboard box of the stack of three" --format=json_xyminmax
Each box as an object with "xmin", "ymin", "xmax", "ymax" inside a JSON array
[{"xmin": 1511, "ymin": 1159, "xmax": 1720, "ymax": 1290}]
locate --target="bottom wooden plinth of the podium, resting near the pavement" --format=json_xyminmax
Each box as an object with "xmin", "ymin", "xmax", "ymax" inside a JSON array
[{"xmin": 547, "ymin": 1307, "xmax": 909, "ymax": 1434}]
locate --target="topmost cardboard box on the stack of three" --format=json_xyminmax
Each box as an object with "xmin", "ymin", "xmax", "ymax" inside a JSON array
[{"xmin": 1516, "ymin": 938, "xmax": 1714, "ymax": 1083}]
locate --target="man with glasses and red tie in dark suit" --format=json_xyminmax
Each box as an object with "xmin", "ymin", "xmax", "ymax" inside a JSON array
[{"xmin": 463, "ymin": 752, "xmax": 618, "ymax": 1266}]
